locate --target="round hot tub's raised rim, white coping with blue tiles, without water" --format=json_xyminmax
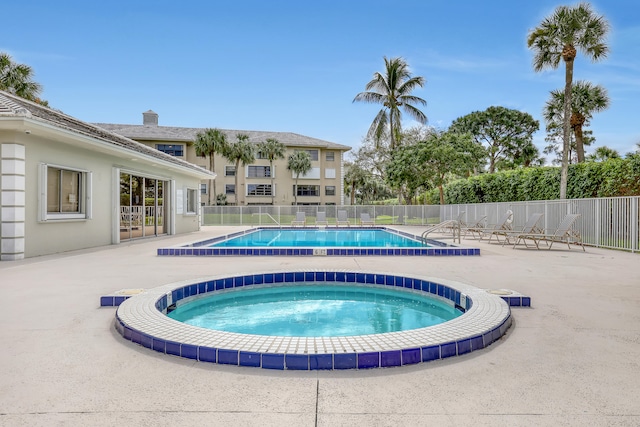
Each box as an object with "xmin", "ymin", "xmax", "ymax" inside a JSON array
[{"xmin": 115, "ymin": 270, "xmax": 511, "ymax": 370}]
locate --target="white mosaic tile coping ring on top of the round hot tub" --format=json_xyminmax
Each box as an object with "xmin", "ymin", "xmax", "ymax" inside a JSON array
[{"xmin": 116, "ymin": 269, "xmax": 510, "ymax": 354}]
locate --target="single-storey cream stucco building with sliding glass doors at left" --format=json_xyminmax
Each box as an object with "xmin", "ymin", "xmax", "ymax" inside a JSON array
[{"xmin": 0, "ymin": 91, "xmax": 215, "ymax": 260}]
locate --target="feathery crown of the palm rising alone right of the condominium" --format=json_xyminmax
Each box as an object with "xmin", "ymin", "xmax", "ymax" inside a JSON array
[{"xmin": 353, "ymin": 56, "xmax": 427, "ymax": 150}]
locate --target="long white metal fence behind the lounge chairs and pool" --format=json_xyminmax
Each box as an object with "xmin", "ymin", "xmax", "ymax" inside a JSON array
[{"xmin": 201, "ymin": 196, "xmax": 640, "ymax": 252}]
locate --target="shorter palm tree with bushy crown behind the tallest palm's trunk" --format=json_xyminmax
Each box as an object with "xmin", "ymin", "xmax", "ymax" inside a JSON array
[{"xmin": 544, "ymin": 80, "xmax": 610, "ymax": 163}]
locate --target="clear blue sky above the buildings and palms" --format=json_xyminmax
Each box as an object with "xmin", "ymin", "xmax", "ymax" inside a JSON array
[{"xmin": 5, "ymin": 0, "xmax": 640, "ymax": 161}]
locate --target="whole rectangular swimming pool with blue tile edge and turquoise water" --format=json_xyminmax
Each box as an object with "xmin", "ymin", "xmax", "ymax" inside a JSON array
[{"xmin": 157, "ymin": 227, "xmax": 480, "ymax": 256}]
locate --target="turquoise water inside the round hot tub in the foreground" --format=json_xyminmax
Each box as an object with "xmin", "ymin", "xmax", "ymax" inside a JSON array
[{"xmin": 168, "ymin": 282, "xmax": 462, "ymax": 337}]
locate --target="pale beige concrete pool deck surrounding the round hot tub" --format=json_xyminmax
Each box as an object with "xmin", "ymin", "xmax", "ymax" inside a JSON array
[{"xmin": 0, "ymin": 227, "xmax": 640, "ymax": 427}]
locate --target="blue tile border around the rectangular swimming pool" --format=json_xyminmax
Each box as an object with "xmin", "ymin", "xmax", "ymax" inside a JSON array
[{"xmin": 156, "ymin": 226, "xmax": 480, "ymax": 256}]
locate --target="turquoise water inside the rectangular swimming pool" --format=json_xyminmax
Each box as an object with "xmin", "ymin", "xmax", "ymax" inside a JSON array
[{"xmin": 210, "ymin": 229, "xmax": 426, "ymax": 248}]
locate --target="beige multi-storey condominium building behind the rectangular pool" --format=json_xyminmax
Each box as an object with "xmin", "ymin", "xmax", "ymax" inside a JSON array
[{"xmin": 96, "ymin": 110, "xmax": 351, "ymax": 205}]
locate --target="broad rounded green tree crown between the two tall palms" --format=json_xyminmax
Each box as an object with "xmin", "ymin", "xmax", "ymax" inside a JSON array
[{"xmin": 449, "ymin": 106, "xmax": 540, "ymax": 173}]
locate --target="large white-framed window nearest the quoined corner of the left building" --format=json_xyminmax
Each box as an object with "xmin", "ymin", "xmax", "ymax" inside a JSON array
[{"xmin": 39, "ymin": 164, "xmax": 91, "ymax": 221}]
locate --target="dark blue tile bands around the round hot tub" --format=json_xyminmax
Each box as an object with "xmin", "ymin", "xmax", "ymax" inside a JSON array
[{"xmin": 115, "ymin": 271, "xmax": 512, "ymax": 370}]
